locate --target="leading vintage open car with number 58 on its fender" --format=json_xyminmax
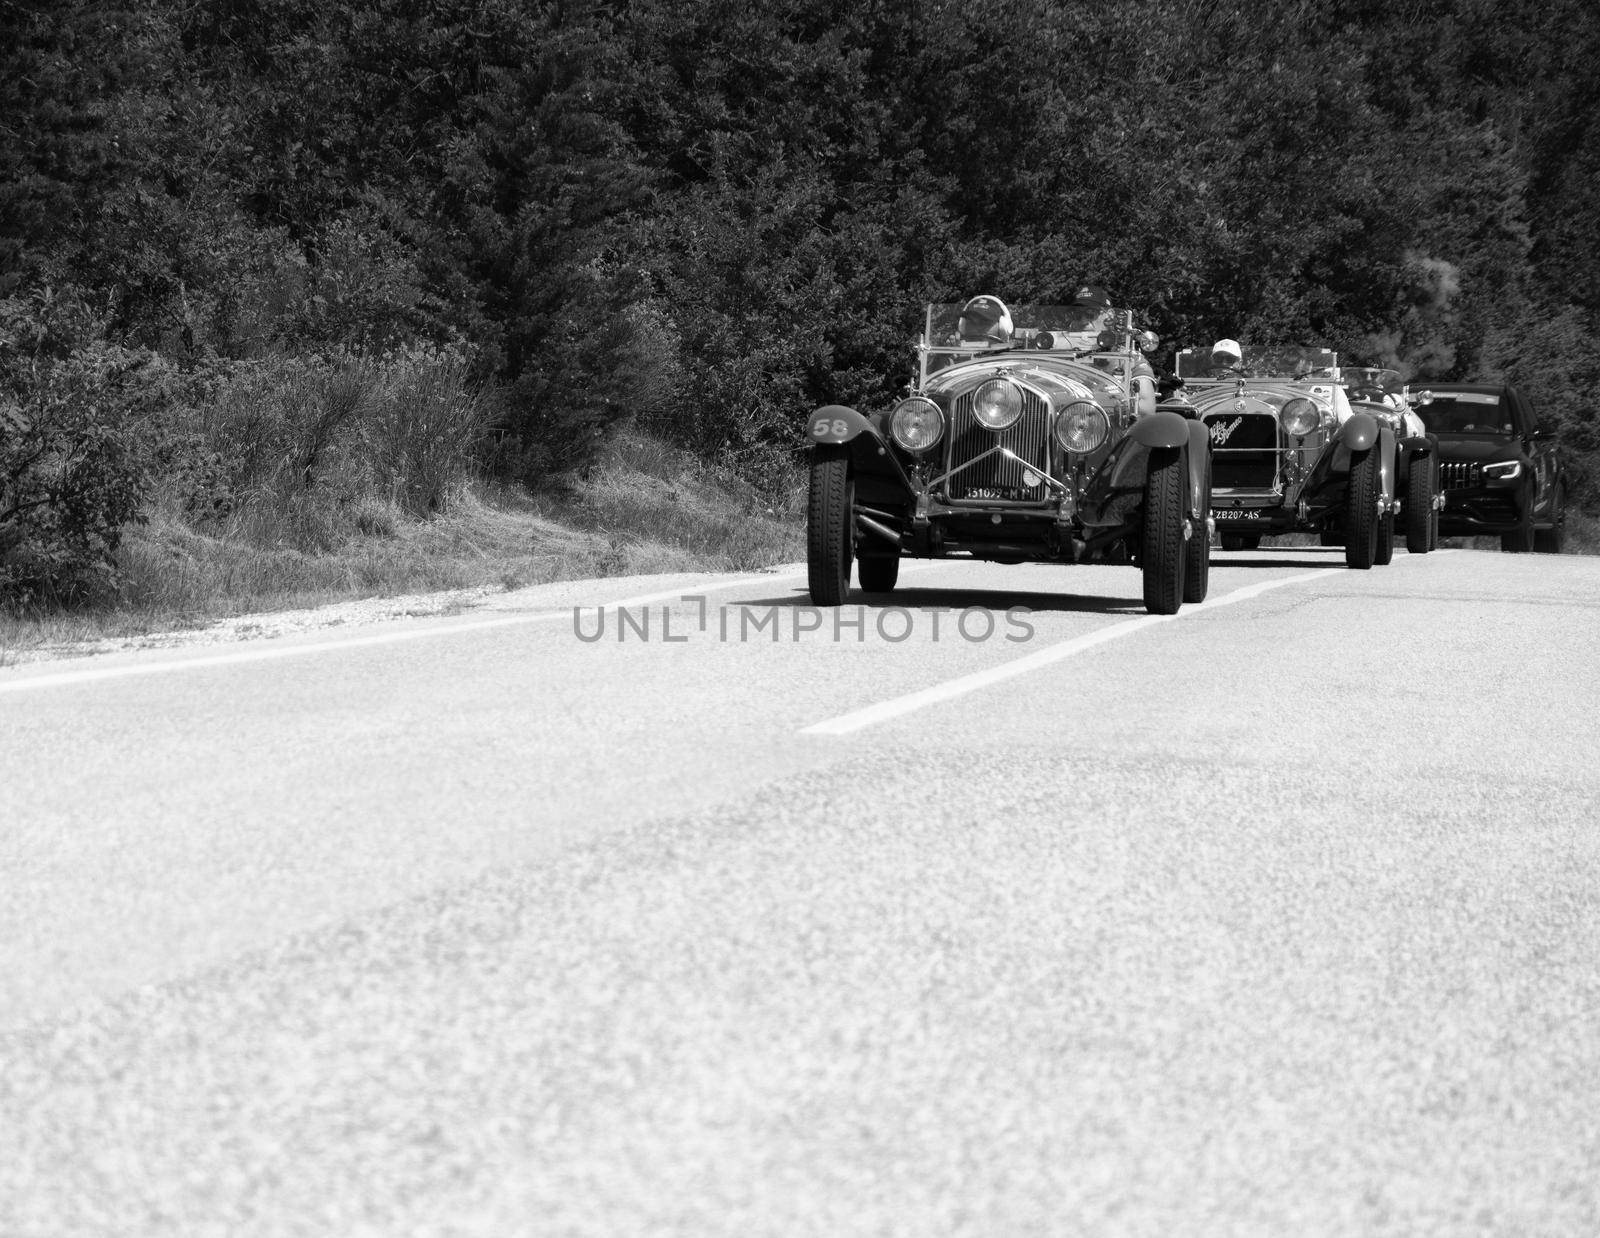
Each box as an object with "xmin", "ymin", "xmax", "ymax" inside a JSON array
[{"xmin": 806, "ymin": 298, "xmax": 1211, "ymax": 614}]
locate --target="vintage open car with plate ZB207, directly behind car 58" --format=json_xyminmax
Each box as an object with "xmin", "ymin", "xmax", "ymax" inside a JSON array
[{"xmin": 1174, "ymin": 345, "xmax": 1400, "ymax": 568}]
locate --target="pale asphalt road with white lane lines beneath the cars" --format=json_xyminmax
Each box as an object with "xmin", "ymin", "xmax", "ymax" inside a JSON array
[{"xmin": 0, "ymin": 549, "xmax": 1600, "ymax": 1238}]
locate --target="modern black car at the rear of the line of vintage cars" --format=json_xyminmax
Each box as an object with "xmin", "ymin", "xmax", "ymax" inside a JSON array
[{"xmin": 1411, "ymin": 382, "xmax": 1566, "ymax": 555}]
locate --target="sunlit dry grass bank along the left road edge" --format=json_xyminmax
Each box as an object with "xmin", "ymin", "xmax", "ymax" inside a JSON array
[{"xmin": 0, "ymin": 433, "xmax": 805, "ymax": 661}]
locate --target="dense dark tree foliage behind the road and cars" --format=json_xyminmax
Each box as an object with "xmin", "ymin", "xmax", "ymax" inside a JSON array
[{"xmin": 0, "ymin": 0, "xmax": 1600, "ymax": 591}]
